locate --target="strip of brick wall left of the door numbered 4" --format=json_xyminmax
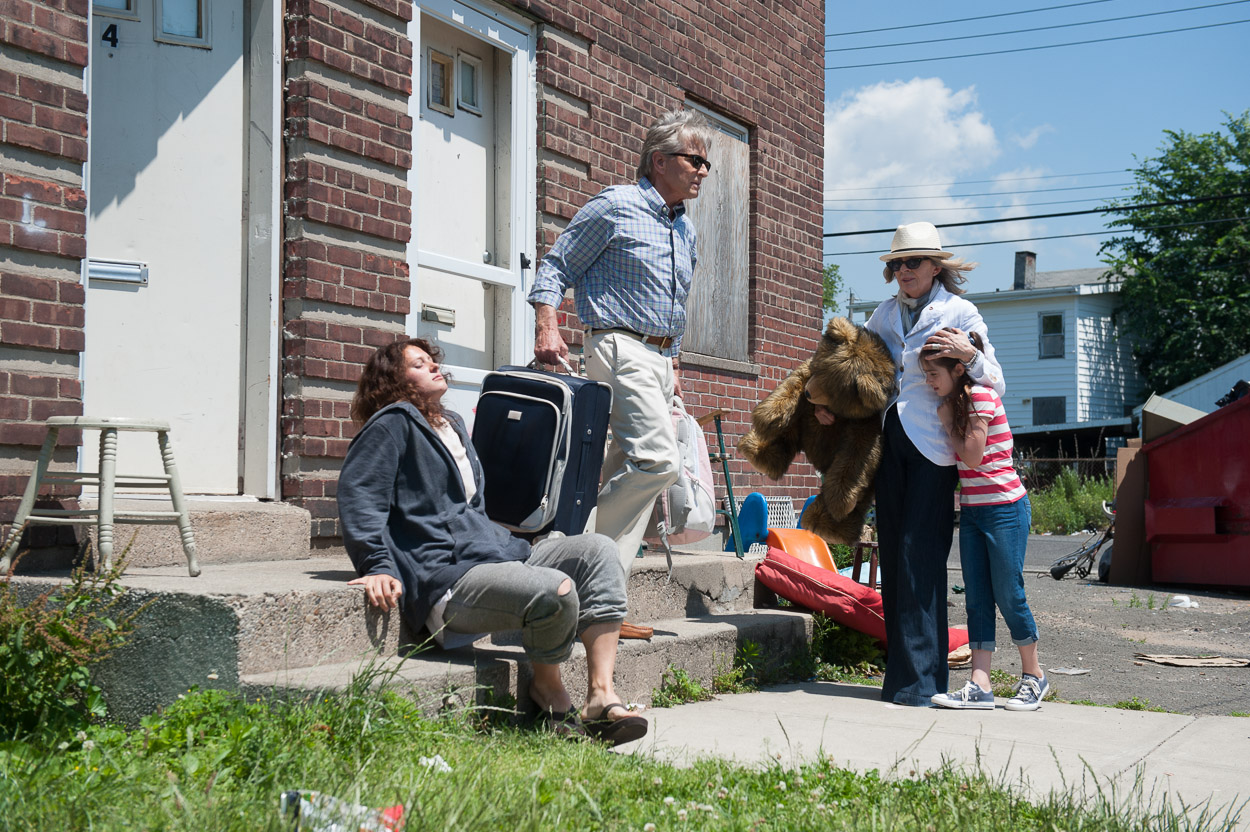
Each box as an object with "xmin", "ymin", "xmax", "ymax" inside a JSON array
[{"xmin": 0, "ymin": 0, "xmax": 88, "ymax": 546}]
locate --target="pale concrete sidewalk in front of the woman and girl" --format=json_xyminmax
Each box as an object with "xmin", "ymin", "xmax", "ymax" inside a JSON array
[{"xmin": 620, "ymin": 682, "xmax": 1250, "ymax": 830}]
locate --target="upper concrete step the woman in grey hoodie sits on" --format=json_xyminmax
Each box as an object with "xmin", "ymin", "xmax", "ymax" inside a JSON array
[{"xmin": 14, "ymin": 552, "xmax": 770, "ymax": 717}]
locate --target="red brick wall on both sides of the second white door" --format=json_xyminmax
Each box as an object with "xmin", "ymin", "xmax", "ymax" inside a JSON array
[{"xmin": 283, "ymin": 0, "xmax": 824, "ymax": 545}]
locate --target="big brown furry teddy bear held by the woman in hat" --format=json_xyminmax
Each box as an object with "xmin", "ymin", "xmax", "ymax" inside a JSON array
[{"xmin": 738, "ymin": 317, "xmax": 895, "ymax": 543}]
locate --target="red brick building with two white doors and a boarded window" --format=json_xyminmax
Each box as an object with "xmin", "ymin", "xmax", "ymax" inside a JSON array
[{"xmin": 0, "ymin": 0, "xmax": 824, "ymax": 545}]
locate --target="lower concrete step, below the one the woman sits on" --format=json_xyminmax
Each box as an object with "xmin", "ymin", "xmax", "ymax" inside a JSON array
[{"xmin": 239, "ymin": 610, "xmax": 811, "ymax": 712}]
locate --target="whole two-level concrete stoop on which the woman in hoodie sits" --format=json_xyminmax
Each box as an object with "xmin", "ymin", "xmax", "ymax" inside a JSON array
[{"xmin": 14, "ymin": 552, "xmax": 810, "ymax": 722}]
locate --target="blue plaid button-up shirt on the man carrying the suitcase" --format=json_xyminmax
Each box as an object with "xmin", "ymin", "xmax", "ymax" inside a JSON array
[{"xmin": 529, "ymin": 177, "xmax": 696, "ymax": 356}]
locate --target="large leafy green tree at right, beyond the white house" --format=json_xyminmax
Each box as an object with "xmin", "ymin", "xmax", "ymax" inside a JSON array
[{"xmin": 1101, "ymin": 110, "xmax": 1250, "ymax": 391}]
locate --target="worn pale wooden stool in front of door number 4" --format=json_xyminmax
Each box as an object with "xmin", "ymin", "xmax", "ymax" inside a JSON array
[{"xmin": 0, "ymin": 416, "xmax": 200, "ymax": 577}]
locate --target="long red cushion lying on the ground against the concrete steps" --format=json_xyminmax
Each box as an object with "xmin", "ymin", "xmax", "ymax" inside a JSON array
[{"xmin": 755, "ymin": 546, "xmax": 968, "ymax": 650}]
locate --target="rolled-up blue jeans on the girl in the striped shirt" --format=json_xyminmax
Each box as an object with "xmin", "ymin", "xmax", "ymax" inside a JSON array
[{"xmin": 959, "ymin": 495, "xmax": 1038, "ymax": 651}]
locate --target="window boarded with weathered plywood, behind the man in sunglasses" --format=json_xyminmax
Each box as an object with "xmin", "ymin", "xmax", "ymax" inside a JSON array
[{"xmin": 681, "ymin": 107, "xmax": 751, "ymax": 370}]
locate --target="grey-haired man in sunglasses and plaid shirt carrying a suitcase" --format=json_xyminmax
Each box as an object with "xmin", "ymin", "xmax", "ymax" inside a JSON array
[{"xmin": 529, "ymin": 110, "xmax": 714, "ymax": 638}]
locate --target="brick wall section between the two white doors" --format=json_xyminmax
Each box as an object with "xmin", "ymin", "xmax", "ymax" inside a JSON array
[{"xmin": 281, "ymin": 0, "xmax": 413, "ymax": 546}]
